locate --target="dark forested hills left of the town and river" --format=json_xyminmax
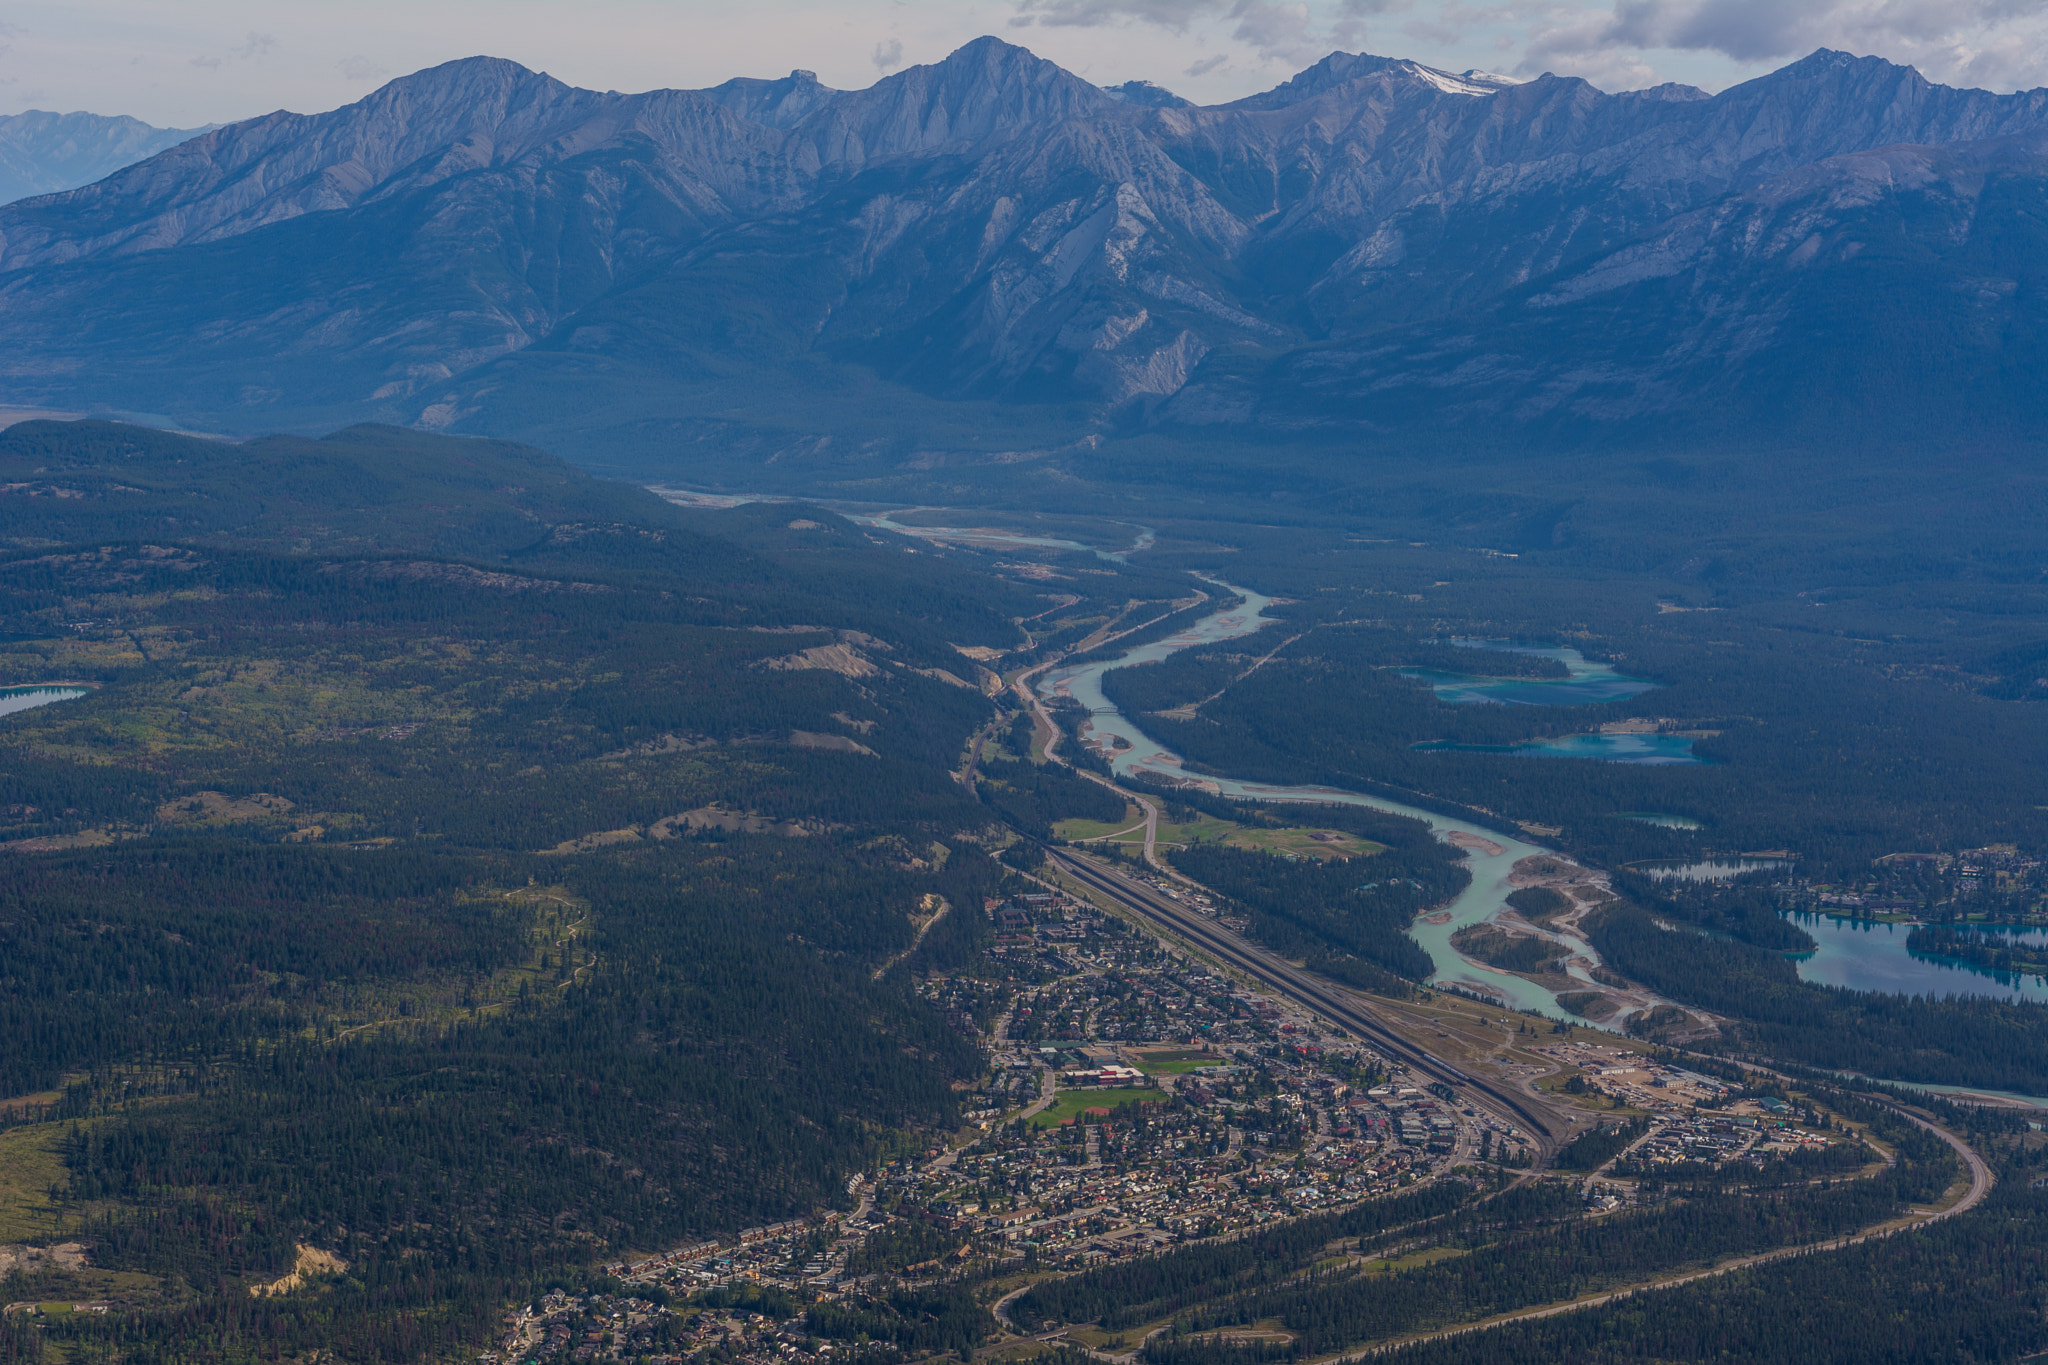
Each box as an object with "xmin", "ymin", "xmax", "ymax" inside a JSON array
[{"xmin": 0, "ymin": 424, "xmax": 1186, "ymax": 1363}]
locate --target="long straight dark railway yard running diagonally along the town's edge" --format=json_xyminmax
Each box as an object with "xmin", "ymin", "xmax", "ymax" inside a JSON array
[{"xmin": 1047, "ymin": 847, "xmax": 1561, "ymax": 1162}]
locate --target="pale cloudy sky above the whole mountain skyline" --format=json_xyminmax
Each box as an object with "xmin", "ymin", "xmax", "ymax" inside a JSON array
[{"xmin": 0, "ymin": 0, "xmax": 2048, "ymax": 127}]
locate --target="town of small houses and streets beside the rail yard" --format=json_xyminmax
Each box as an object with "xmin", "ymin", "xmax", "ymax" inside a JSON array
[{"xmin": 464, "ymin": 839, "xmax": 1998, "ymax": 1365}]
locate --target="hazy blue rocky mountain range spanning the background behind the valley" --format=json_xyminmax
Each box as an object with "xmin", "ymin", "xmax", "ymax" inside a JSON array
[{"xmin": 0, "ymin": 39, "xmax": 2048, "ymax": 480}]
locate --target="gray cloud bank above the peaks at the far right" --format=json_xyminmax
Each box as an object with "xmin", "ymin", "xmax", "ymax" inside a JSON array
[{"xmin": 1522, "ymin": 0, "xmax": 2048, "ymax": 88}]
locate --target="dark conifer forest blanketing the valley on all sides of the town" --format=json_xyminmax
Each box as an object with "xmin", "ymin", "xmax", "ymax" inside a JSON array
[{"xmin": 0, "ymin": 424, "xmax": 2048, "ymax": 1365}]
